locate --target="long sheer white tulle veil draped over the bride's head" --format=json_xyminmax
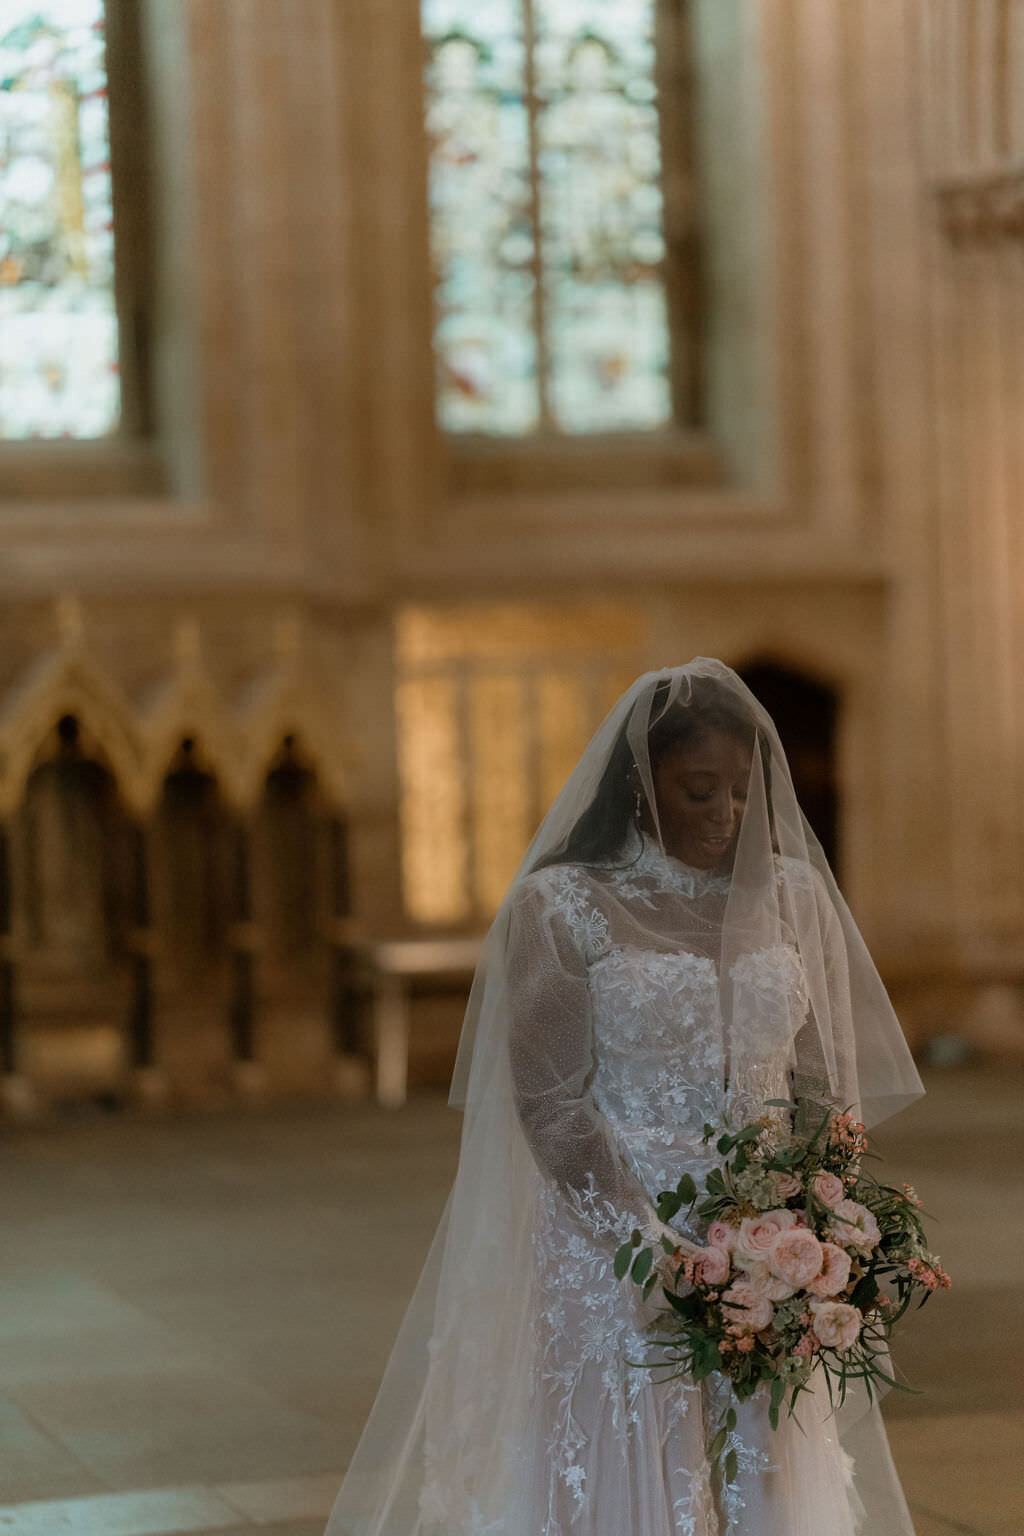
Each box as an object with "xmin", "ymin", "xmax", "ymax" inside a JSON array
[{"xmin": 327, "ymin": 657, "xmax": 923, "ymax": 1536}]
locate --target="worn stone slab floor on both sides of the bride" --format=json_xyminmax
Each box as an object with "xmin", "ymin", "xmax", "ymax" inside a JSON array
[{"xmin": 0, "ymin": 1072, "xmax": 1024, "ymax": 1536}]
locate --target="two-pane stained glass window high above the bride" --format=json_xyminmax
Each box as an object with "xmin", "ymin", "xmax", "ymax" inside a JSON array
[{"xmin": 422, "ymin": 0, "xmax": 671, "ymax": 435}]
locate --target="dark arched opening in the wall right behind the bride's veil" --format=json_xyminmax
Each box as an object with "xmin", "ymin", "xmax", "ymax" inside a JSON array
[{"xmin": 735, "ymin": 650, "xmax": 843, "ymax": 869}]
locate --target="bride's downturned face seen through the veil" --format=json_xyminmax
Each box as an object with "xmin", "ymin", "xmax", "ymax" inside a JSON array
[{"xmin": 654, "ymin": 728, "xmax": 752, "ymax": 869}]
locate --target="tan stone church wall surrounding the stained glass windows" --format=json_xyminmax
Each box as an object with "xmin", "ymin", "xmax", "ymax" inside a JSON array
[{"xmin": 0, "ymin": 0, "xmax": 1024, "ymax": 1105}]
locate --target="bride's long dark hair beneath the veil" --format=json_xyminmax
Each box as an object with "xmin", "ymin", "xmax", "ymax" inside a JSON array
[{"xmin": 533, "ymin": 677, "xmax": 771, "ymax": 869}]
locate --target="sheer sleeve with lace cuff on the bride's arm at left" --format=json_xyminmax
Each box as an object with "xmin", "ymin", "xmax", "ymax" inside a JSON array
[{"xmin": 507, "ymin": 871, "xmax": 663, "ymax": 1241}]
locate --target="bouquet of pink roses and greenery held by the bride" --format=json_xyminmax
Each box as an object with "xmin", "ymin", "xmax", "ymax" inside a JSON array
[{"xmin": 616, "ymin": 1100, "xmax": 950, "ymax": 1482}]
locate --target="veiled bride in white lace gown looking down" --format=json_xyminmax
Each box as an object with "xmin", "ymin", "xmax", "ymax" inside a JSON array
[{"xmin": 327, "ymin": 657, "xmax": 921, "ymax": 1536}]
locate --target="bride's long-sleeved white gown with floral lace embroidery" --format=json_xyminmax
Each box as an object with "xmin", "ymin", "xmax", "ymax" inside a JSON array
[{"xmin": 497, "ymin": 840, "xmax": 912, "ymax": 1536}]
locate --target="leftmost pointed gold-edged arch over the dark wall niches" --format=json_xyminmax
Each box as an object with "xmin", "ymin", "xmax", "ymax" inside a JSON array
[{"xmin": 0, "ymin": 656, "xmax": 144, "ymax": 816}]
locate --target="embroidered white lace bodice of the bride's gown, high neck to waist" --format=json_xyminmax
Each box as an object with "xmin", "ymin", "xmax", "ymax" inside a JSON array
[{"xmin": 509, "ymin": 839, "xmax": 808, "ymax": 1228}]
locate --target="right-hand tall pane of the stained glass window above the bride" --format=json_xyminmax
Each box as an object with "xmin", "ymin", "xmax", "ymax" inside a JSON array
[{"xmin": 533, "ymin": 0, "xmax": 671, "ymax": 432}]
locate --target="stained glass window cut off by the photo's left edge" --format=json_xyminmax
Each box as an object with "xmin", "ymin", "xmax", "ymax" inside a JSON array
[{"xmin": 0, "ymin": 0, "xmax": 120, "ymax": 439}]
